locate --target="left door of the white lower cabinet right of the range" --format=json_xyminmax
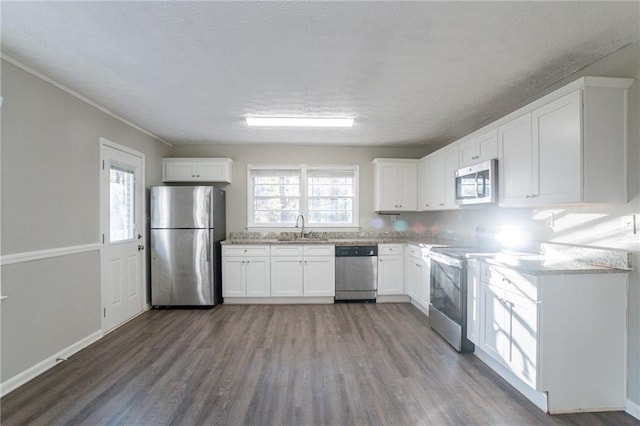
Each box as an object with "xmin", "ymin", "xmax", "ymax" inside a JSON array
[{"xmin": 480, "ymin": 284, "xmax": 510, "ymax": 364}]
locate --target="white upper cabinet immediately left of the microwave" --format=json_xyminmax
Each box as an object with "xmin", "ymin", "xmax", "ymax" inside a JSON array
[{"xmin": 421, "ymin": 143, "xmax": 459, "ymax": 210}]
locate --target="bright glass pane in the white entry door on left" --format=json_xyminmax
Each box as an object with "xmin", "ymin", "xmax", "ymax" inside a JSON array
[{"xmin": 109, "ymin": 165, "xmax": 136, "ymax": 242}]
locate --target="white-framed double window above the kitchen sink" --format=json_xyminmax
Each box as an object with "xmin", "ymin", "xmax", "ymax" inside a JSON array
[{"xmin": 247, "ymin": 165, "xmax": 358, "ymax": 228}]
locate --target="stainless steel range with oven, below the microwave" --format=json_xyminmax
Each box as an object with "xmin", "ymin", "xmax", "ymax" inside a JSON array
[{"xmin": 429, "ymin": 247, "xmax": 477, "ymax": 352}]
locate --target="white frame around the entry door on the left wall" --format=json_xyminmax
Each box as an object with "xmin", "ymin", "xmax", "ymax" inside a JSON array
[{"xmin": 98, "ymin": 137, "xmax": 150, "ymax": 334}]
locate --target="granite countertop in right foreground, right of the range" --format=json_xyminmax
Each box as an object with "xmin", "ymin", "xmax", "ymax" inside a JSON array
[{"xmin": 469, "ymin": 253, "xmax": 629, "ymax": 276}]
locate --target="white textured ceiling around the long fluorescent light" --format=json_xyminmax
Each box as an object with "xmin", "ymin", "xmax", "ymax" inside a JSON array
[{"xmin": 2, "ymin": 1, "xmax": 640, "ymax": 146}]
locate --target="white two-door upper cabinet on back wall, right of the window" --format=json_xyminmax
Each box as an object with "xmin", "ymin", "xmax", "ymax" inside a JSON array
[{"xmin": 373, "ymin": 158, "xmax": 418, "ymax": 212}]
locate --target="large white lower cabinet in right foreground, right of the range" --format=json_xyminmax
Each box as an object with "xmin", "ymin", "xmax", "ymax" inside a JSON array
[{"xmin": 467, "ymin": 262, "xmax": 627, "ymax": 413}]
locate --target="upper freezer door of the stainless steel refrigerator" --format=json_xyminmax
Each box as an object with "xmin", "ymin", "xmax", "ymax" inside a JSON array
[{"xmin": 150, "ymin": 186, "xmax": 214, "ymax": 229}]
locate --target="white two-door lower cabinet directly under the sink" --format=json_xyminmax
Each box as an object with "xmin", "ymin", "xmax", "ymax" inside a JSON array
[{"xmin": 271, "ymin": 245, "xmax": 335, "ymax": 297}]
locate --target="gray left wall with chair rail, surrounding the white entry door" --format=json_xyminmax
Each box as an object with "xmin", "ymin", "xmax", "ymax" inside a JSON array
[{"xmin": 0, "ymin": 61, "xmax": 169, "ymax": 381}]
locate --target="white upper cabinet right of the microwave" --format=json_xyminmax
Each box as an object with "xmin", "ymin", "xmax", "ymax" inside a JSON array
[{"xmin": 498, "ymin": 77, "xmax": 633, "ymax": 207}]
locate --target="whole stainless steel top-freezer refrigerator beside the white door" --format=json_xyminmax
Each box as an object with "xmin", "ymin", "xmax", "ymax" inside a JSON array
[{"xmin": 150, "ymin": 186, "xmax": 226, "ymax": 306}]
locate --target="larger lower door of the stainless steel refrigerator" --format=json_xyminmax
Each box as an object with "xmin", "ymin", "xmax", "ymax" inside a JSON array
[{"xmin": 151, "ymin": 229, "xmax": 214, "ymax": 306}]
